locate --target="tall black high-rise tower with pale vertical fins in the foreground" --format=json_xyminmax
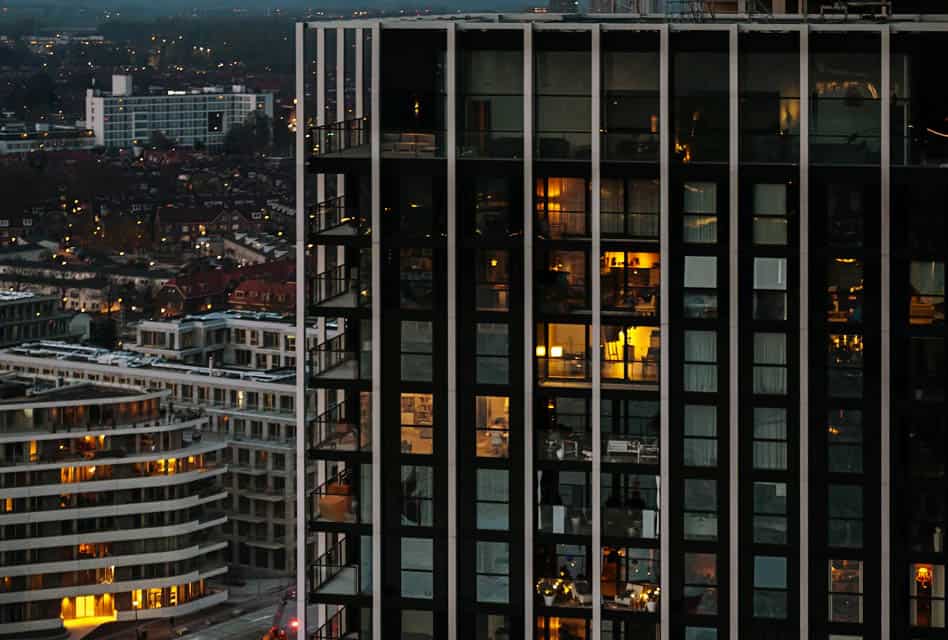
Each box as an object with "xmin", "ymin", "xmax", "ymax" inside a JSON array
[{"xmin": 297, "ymin": 8, "xmax": 948, "ymax": 640}]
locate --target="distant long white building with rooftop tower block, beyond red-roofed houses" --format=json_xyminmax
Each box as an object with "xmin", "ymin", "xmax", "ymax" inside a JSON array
[{"xmin": 86, "ymin": 74, "xmax": 273, "ymax": 149}]
